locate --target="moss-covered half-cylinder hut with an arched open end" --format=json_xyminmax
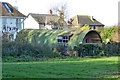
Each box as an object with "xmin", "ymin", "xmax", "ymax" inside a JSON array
[{"xmin": 16, "ymin": 29, "xmax": 102, "ymax": 47}]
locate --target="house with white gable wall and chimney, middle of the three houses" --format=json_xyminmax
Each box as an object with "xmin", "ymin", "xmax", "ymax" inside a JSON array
[{"xmin": 25, "ymin": 10, "xmax": 67, "ymax": 29}]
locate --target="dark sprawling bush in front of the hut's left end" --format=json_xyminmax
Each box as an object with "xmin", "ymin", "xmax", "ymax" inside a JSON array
[{"xmin": 2, "ymin": 42, "xmax": 60, "ymax": 58}]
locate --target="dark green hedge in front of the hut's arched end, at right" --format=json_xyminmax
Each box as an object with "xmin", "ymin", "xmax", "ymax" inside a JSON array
[{"xmin": 74, "ymin": 43, "xmax": 120, "ymax": 57}]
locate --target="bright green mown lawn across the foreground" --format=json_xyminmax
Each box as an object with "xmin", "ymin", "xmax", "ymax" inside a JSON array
[{"xmin": 2, "ymin": 57, "xmax": 120, "ymax": 78}]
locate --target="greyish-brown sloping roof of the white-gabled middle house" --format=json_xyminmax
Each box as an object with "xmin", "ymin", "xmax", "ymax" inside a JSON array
[{"xmin": 29, "ymin": 13, "xmax": 59, "ymax": 24}]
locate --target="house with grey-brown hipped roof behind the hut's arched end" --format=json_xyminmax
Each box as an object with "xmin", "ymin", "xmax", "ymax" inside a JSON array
[{"xmin": 68, "ymin": 15, "xmax": 104, "ymax": 29}]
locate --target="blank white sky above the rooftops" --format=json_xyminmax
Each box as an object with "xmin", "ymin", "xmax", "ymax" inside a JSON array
[{"xmin": 0, "ymin": 0, "xmax": 120, "ymax": 26}]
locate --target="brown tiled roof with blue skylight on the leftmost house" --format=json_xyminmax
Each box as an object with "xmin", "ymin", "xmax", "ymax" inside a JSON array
[{"xmin": 0, "ymin": 2, "xmax": 26, "ymax": 17}]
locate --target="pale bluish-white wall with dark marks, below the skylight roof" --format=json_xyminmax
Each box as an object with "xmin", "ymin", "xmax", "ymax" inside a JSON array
[{"xmin": 1, "ymin": 18, "xmax": 22, "ymax": 41}]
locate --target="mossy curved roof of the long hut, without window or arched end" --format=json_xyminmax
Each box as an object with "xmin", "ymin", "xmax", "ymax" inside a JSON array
[{"xmin": 16, "ymin": 29, "xmax": 101, "ymax": 47}]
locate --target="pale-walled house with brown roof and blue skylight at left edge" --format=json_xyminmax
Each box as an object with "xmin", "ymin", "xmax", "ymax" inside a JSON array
[{"xmin": 0, "ymin": 2, "xmax": 27, "ymax": 41}]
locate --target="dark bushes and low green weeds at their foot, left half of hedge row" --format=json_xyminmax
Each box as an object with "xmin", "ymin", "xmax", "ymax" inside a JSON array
[{"xmin": 2, "ymin": 42, "xmax": 61, "ymax": 61}]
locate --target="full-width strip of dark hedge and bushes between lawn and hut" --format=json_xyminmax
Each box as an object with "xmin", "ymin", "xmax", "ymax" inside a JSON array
[{"xmin": 2, "ymin": 42, "xmax": 120, "ymax": 62}]
